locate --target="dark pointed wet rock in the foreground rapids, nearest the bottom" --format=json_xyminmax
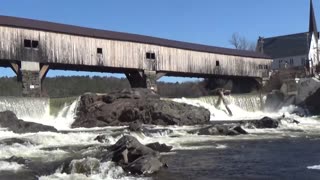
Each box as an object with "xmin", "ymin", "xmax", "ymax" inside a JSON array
[{"xmin": 108, "ymin": 136, "xmax": 164, "ymax": 174}]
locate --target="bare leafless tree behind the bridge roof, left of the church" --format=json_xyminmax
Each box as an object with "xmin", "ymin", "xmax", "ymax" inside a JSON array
[{"xmin": 229, "ymin": 33, "xmax": 256, "ymax": 51}]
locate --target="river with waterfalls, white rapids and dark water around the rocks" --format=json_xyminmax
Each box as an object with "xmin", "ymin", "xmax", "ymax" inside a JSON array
[{"xmin": 0, "ymin": 95, "xmax": 320, "ymax": 180}]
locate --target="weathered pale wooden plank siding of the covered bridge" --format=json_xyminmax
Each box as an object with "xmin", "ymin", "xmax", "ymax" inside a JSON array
[{"xmin": 0, "ymin": 26, "xmax": 271, "ymax": 77}]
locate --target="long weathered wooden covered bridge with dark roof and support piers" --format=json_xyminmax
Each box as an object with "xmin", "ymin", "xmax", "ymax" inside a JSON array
[{"xmin": 0, "ymin": 16, "xmax": 272, "ymax": 96}]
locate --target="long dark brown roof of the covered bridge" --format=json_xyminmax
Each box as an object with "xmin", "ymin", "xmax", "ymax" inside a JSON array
[{"xmin": 0, "ymin": 15, "xmax": 271, "ymax": 59}]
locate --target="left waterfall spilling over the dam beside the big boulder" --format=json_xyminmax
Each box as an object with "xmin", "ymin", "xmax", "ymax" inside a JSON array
[{"xmin": 0, "ymin": 97, "xmax": 80, "ymax": 130}]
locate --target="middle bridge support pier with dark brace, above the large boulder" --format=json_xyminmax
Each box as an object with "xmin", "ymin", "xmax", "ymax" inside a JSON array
[{"xmin": 125, "ymin": 70, "xmax": 157, "ymax": 91}]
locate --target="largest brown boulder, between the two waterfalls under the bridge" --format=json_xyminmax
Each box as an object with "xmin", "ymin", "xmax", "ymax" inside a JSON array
[{"xmin": 72, "ymin": 88, "xmax": 210, "ymax": 128}]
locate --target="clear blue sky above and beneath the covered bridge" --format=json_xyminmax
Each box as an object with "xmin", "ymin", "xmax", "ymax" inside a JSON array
[{"xmin": 0, "ymin": 0, "xmax": 320, "ymax": 81}]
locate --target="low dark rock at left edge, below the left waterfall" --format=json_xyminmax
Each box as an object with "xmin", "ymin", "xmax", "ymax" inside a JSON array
[{"xmin": 0, "ymin": 111, "xmax": 57, "ymax": 133}]
